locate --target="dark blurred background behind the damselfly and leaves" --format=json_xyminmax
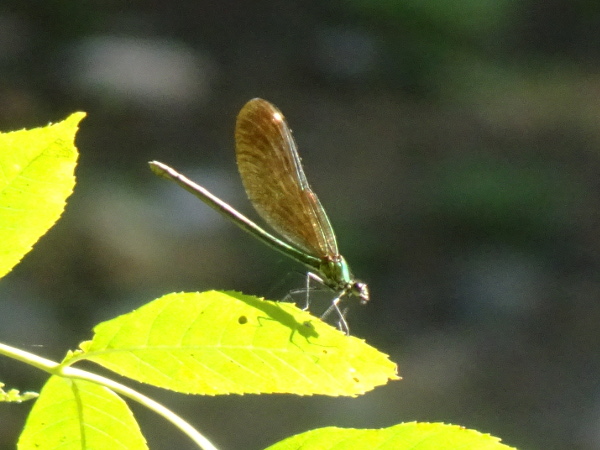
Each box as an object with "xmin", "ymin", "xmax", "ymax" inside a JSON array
[{"xmin": 0, "ymin": 0, "xmax": 600, "ymax": 450}]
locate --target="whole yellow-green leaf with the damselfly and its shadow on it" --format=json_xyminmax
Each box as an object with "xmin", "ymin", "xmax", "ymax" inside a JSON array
[{"xmin": 76, "ymin": 291, "xmax": 398, "ymax": 396}]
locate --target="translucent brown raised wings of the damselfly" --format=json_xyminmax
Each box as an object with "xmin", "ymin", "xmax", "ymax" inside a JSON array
[{"xmin": 235, "ymin": 98, "xmax": 338, "ymax": 257}]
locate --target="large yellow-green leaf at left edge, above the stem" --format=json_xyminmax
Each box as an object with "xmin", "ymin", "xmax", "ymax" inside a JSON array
[{"xmin": 0, "ymin": 113, "xmax": 85, "ymax": 277}]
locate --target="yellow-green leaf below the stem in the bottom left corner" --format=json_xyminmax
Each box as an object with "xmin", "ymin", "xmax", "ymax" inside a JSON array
[{"xmin": 18, "ymin": 376, "xmax": 148, "ymax": 450}]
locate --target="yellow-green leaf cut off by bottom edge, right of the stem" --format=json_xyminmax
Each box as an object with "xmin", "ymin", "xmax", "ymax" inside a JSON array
[{"xmin": 267, "ymin": 422, "xmax": 514, "ymax": 450}]
